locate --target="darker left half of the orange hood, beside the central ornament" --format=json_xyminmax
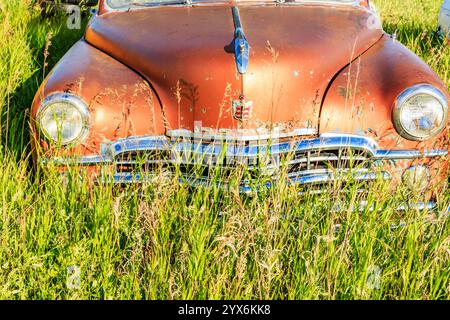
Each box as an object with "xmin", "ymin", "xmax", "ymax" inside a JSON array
[{"xmin": 86, "ymin": 7, "xmax": 240, "ymax": 130}]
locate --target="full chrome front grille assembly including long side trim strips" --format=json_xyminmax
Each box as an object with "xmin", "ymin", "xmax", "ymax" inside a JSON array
[{"xmin": 43, "ymin": 134, "xmax": 448, "ymax": 193}]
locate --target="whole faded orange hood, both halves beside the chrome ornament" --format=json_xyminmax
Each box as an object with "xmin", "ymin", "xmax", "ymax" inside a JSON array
[{"xmin": 86, "ymin": 5, "xmax": 383, "ymax": 135}]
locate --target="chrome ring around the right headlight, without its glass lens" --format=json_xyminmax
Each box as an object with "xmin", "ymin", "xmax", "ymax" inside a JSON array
[{"xmin": 392, "ymin": 84, "xmax": 448, "ymax": 141}]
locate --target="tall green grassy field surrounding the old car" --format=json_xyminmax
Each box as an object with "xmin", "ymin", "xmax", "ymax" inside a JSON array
[{"xmin": 0, "ymin": 0, "xmax": 450, "ymax": 299}]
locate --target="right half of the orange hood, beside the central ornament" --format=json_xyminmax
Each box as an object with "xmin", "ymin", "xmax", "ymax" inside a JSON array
[{"xmin": 240, "ymin": 6, "xmax": 382, "ymax": 128}]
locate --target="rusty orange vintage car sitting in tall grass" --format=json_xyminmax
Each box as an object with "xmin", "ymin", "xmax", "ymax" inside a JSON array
[{"xmin": 31, "ymin": 0, "xmax": 449, "ymax": 204}]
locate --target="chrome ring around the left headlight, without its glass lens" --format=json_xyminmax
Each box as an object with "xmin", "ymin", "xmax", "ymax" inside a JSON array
[{"xmin": 36, "ymin": 92, "xmax": 90, "ymax": 146}]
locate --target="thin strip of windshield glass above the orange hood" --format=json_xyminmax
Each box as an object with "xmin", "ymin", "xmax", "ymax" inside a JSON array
[{"xmin": 107, "ymin": 0, "xmax": 358, "ymax": 9}]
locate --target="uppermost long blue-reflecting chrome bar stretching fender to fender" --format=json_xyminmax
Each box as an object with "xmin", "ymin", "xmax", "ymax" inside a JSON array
[{"xmin": 41, "ymin": 134, "xmax": 448, "ymax": 165}]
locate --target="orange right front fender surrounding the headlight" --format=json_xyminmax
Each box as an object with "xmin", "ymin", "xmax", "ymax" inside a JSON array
[{"xmin": 320, "ymin": 35, "xmax": 450, "ymax": 149}]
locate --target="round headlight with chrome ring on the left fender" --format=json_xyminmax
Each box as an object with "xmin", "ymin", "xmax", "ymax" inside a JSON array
[{"xmin": 37, "ymin": 93, "xmax": 89, "ymax": 145}]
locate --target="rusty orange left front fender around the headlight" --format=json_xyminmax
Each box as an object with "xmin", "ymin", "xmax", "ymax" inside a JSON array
[{"xmin": 31, "ymin": 40, "xmax": 164, "ymax": 155}]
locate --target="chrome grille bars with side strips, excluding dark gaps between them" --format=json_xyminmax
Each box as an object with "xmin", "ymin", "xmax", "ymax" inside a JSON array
[{"xmin": 43, "ymin": 134, "xmax": 448, "ymax": 193}]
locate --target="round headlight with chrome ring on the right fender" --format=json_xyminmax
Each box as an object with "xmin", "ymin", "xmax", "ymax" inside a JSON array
[{"xmin": 393, "ymin": 84, "xmax": 448, "ymax": 141}]
